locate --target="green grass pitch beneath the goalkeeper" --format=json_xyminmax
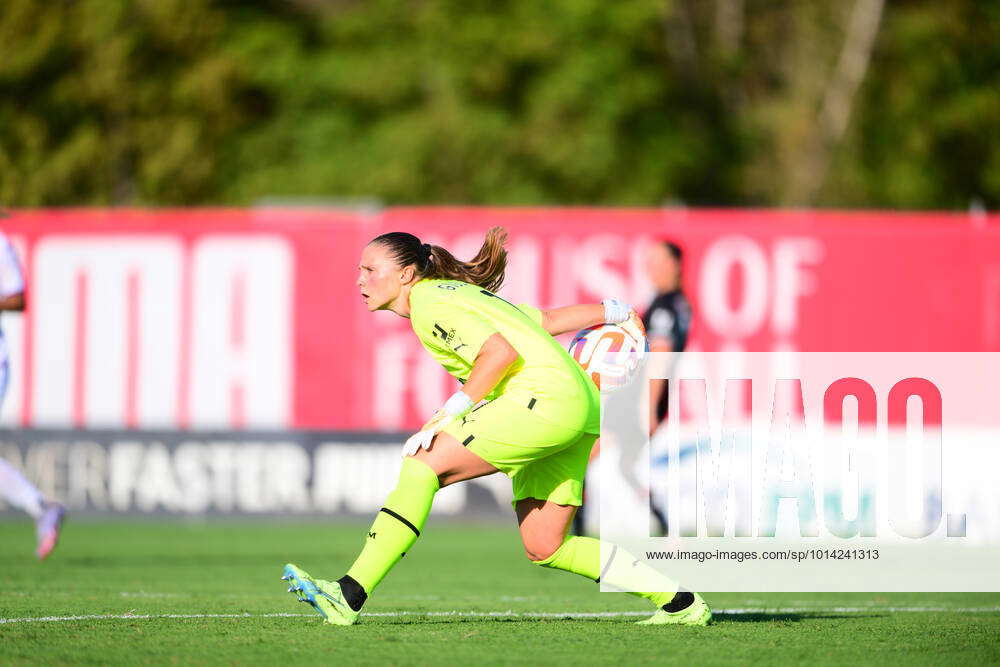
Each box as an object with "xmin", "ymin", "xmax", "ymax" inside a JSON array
[{"xmin": 0, "ymin": 518, "xmax": 1000, "ymax": 665}]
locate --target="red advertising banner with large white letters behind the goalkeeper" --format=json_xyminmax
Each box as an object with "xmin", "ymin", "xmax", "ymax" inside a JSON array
[{"xmin": 0, "ymin": 208, "xmax": 1000, "ymax": 430}]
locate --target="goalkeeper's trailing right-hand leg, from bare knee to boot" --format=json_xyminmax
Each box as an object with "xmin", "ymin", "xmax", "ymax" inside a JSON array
[{"xmin": 517, "ymin": 498, "xmax": 712, "ymax": 625}]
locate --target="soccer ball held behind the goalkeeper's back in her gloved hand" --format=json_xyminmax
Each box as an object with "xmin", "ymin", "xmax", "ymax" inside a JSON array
[{"xmin": 569, "ymin": 324, "xmax": 649, "ymax": 394}]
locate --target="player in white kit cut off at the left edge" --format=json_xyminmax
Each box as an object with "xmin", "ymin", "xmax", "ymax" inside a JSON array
[{"xmin": 0, "ymin": 232, "xmax": 66, "ymax": 558}]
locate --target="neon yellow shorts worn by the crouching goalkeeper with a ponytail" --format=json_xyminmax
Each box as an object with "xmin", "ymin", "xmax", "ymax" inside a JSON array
[{"xmin": 444, "ymin": 392, "xmax": 598, "ymax": 506}]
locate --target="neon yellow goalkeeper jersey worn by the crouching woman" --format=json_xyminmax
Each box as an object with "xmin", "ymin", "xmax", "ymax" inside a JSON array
[{"xmin": 410, "ymin": 279, "xmax": 601, "ymax": 433}]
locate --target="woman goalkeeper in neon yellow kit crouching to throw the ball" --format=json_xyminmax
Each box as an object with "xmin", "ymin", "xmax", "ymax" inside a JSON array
[{"xmin": 282, "ymin": 227, "xmax": 712, "ymax": 625}]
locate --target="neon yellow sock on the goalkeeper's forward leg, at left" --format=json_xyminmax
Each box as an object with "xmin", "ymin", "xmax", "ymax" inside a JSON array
[{"xmin": 347, "ymin": 457, "xmax": 441, "ymax": 595}]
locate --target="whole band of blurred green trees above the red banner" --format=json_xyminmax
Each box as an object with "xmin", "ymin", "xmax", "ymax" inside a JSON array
[{"xmin": 0, "ymin": 0, "xmax": 1000, "ymax": 208}]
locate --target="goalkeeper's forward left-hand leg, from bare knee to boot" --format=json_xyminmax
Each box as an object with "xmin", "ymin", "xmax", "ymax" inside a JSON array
[{"xmin": 283, "ymin": 433, "xmax": 497, "ymax": 625}]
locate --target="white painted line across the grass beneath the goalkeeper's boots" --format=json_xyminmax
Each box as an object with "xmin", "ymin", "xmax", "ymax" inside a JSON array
[{"xmin": 0, "ymin": 607, "xmax": 1000, "ymax": 625}]
